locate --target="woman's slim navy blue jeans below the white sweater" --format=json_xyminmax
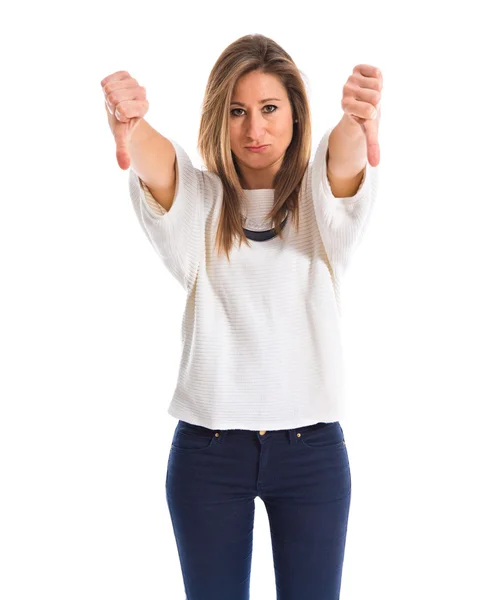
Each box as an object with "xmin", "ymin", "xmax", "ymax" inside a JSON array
[{"xmin": 166, "ymin": 421, "xmax": 351, "ymax": 600}]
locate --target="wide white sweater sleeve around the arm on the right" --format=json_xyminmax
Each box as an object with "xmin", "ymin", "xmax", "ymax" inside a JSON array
[{"xmin": 311, "ymin": 129, "xmax": 378, "ymax": 274}]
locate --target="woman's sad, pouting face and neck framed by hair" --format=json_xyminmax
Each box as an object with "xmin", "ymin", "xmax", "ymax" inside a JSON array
[{"xmin": 229, "ymin": 71, "xmax": 293, "ymax": 189}]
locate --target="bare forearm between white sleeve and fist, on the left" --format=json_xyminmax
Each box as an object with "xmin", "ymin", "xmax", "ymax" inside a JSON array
[{"xmin": 128, "ymin": 119, "xmax": 176, "ymax": 211}]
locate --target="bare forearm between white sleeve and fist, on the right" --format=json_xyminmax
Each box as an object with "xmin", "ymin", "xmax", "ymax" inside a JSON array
[{"xmin": 326, "ymin": 114, "xmax": 367, "ymax": 198}]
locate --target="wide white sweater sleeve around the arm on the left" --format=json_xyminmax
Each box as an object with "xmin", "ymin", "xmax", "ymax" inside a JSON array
[{"xmin": 129, "ymin": 140, "xmax": 204, "ymax": 291}]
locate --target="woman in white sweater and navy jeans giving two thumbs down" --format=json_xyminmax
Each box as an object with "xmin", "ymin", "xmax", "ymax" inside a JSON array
[{"xmin": 102, "ymin": 35, "xmax": 382, "ymax": 600}]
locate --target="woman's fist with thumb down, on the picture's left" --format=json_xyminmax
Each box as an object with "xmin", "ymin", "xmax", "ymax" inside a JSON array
[{"xmin": 101, "ymin": 71, "xmax": 149, "ymax": 170}]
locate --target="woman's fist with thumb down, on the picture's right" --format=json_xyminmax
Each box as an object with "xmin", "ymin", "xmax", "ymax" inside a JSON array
[{"xmin": 341, "ymin": 65, "xmax": 383, "ymax": 167}]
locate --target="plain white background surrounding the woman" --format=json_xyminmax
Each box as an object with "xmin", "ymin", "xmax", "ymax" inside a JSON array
[{"xmin": 0, "ymin": 1, "xmax": 503, "ymax": 600}]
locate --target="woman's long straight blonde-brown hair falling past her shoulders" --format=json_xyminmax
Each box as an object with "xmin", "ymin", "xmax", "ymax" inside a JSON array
[{"xmin": 198, "ymin": 34, "xmax": 311, "ymax": 260}]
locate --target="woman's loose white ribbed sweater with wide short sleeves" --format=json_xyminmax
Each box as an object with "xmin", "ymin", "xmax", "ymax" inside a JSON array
[{"xmin": 129, "ymin": 128, "xmax": 378, "ymax": 431}]
